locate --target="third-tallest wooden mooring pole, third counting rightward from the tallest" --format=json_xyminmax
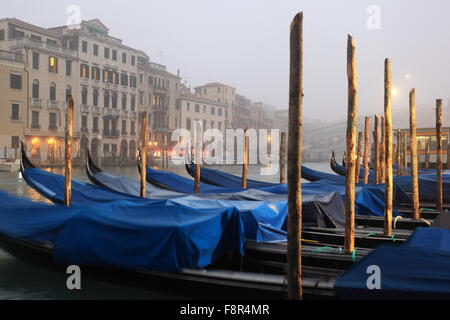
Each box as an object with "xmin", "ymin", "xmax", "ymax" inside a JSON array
[{"xmin": 384, "ymin": 59, "xmax": 394, "ymax": 237}]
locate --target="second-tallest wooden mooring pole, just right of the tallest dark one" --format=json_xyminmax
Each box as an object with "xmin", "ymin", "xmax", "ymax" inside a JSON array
[{"xmin": 345, "ymin": 35, "xmax": 358, "ymax": 253}]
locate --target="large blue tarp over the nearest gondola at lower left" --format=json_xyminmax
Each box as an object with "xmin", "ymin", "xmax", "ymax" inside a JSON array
[{"xmin": 0, "ymin": 192, "xmax": 244, "ymax": 271}]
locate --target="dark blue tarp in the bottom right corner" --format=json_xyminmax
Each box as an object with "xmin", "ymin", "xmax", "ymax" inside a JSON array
[{"xmin": 335, "ymin": 228, "xmax": 450, "ymax": 299}]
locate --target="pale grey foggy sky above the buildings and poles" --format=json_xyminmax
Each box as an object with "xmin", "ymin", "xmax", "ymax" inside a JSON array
[{"xmin": 0, "ymin": 0, "xmax": 450, "ymax": 125}]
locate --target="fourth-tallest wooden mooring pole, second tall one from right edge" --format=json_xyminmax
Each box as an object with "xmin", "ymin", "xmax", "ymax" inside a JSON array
[{"xmin": 405, "ymin": 89, "xmax": 420, "ymax": 220}]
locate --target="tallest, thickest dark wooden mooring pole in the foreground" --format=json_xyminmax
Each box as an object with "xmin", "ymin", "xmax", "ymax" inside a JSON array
[{"xmin": 287, "ymin": 12, "xmax": 303, "ymax": 300}]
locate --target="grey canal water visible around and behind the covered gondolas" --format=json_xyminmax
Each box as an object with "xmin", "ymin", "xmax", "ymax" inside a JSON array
[{"xmin": 0, "ymin": 163, "xmax": 330, "ymax": 300}]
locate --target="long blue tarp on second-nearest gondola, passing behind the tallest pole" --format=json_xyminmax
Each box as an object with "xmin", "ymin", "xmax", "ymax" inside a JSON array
[{"xmin": 23, "ymin": 168, "xmax": 344, "ymax": 241}]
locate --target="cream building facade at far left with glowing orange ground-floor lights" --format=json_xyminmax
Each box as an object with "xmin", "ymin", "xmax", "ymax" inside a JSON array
[{"xmin": 0, "ymin": 19, "xmax": 79, "ymax": 165}]
